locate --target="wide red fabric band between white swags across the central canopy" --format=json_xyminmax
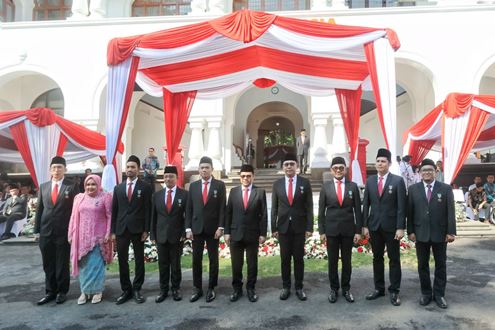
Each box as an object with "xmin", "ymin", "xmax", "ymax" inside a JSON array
[{"xmin": 141, "ymin": 46, "xmax": 370, "ymax": 86}]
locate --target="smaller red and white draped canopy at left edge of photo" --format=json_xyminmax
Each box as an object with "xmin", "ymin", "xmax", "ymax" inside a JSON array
[{"xmin": 0, "ymin": 108, "xmax": 124, "ymax": 186}]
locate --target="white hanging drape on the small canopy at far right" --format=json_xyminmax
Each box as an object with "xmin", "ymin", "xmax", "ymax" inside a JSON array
[{"xmin": 443, "ymin": 111, "xmax": 471, "ymax": 183}]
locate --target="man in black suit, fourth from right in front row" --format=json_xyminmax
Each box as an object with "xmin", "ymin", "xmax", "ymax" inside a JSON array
[{"xmin": 271, "ymin": 153, "xmax": 313, "ymax": 301}]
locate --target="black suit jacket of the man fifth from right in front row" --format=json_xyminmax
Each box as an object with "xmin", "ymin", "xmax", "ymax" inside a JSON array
[{"xmin": 225, "ymin": 185, "xmax": 268, "ymax": 242}]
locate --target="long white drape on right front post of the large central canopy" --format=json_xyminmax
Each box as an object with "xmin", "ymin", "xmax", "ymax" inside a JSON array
[{"xmin": 373, "ymin": 38, "xmax": 399, "ymax": 174}]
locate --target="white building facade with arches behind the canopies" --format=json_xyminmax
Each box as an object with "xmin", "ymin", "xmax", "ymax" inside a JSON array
[{"xmin": 0, "ymin": 0, "xmax": 495, "ymax": 173}]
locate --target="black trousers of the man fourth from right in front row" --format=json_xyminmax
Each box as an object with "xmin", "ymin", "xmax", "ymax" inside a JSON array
[{"xmin": 278, "ymin": 224, "xmax": 306, "ymax": 290}]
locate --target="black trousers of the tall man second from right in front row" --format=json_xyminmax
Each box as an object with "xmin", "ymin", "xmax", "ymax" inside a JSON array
[{"xmin": 370, "ymin": 228, "xmax": 402, "ymax": 293}]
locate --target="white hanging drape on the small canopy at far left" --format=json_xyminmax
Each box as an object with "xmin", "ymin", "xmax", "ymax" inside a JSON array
[{"xmin": 24, "ymin": 120, "xmax": 60, "ymax": 184}]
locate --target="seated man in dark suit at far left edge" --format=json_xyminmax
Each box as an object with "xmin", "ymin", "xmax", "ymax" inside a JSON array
[{"xmin": 0, "ymin": 183, "xmax": 27, "ymax": 240}]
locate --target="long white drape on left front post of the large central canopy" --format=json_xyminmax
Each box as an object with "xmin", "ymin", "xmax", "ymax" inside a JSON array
[{"xmin": 102, "ymin": 57, "xmax": 132, "ymax": 191}]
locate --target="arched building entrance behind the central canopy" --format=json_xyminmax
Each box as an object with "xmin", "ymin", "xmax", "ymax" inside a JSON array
[{"xmin": 246, "ymin": 102, "xmax": 303, "ymax": 168}]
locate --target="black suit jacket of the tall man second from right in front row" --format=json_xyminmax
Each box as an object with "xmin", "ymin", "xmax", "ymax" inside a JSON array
[{"xmin": 363, "ymin": 173, "xmax": 407, "ymax": 232}]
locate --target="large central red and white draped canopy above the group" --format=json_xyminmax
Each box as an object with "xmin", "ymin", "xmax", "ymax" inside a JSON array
[{"xmin": 103, "ymin": 10, "xmax": 400, "ymax": 189}]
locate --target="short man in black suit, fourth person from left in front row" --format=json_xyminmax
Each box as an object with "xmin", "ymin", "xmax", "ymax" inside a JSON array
[{"xmin": 151, "ymin": 165, "xmax": 187, "ymax": 303}]
